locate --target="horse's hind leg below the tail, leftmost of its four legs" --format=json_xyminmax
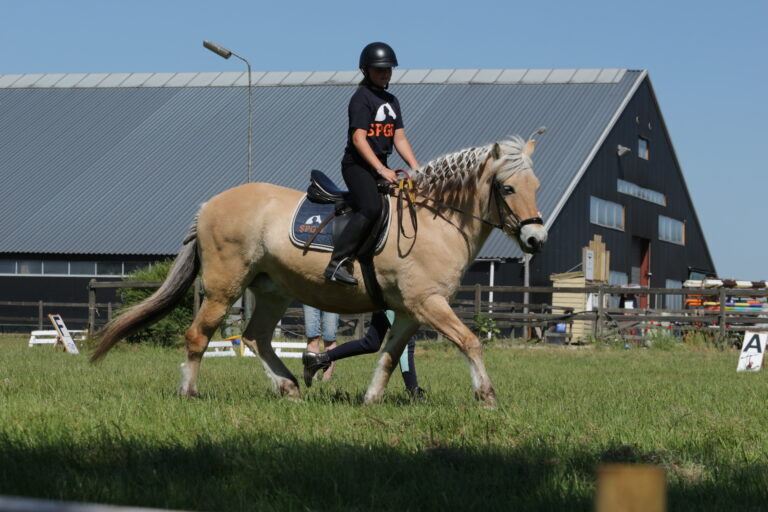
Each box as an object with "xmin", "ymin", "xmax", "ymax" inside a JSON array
[{"xmin": 179, "ymin": 297, "xmax": 229, "ymax": 396}]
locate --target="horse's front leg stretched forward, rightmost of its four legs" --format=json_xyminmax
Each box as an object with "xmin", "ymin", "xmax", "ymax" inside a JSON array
[{"xmin": 415, "ymin": 295, "xmax": 496, "ymax": 408}]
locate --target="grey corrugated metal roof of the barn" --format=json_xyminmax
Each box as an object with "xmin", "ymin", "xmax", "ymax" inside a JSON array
[{"xmin": 0, "ymin": 69, "xmax": 645, "ymax": 258}]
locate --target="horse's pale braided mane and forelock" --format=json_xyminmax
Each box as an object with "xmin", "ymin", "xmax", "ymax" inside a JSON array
[{"xmin": 412, "ymin": 136, "xmax": 532, "ymax": 198}]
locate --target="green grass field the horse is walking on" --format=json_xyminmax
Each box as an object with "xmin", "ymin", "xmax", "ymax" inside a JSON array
[{"xmin": 0, "ymin": 336, "xmax": 768, "ymax": 510}]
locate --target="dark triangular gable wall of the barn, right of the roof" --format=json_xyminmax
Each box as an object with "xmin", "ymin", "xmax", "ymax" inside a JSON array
[{"xmin": 531, "ymin": 79, "xmax": 714, "ymax": 287}]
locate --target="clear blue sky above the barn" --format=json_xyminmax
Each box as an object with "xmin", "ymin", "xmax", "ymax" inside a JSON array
[{"xmin": 0, "ymin": 0, "xmax": 768, "ymax": 279}]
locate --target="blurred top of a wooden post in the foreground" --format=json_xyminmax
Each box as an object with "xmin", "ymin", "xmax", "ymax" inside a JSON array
[{"xmin": 595, "ymin": 464, "xmax": 667, "ymax": 512}]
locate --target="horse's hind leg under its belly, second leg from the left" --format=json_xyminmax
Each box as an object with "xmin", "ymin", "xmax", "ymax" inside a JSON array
[{"xmin": 243, "ymin": 289, "xmax": 301, "ymax": 400}]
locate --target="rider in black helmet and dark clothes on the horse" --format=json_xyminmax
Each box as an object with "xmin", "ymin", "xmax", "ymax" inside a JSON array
[{"xmin": 324, "ymin": 42, "xmax": 419, "ymax": 285}]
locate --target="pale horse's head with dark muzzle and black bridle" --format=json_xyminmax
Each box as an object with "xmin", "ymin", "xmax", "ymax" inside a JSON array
[{"xmin": 486, "ymin": 135, "xmax": 547, "ymax": 253}]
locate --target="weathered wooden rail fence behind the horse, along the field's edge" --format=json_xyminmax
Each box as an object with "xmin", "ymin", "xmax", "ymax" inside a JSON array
[{"xmin": 0, "ymin": 280, "xmax": 768, "ymax": 342}]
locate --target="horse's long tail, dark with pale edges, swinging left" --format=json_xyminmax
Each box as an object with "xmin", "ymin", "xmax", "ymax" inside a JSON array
[{"xmin": 91, "ymin": 217, "xmax": 200, "ymax": 363}]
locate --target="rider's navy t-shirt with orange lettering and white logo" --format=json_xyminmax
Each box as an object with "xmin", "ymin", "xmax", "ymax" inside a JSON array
[{"xmin": 344, "ymin": 86, "xmax": 403, "ymax": 161}]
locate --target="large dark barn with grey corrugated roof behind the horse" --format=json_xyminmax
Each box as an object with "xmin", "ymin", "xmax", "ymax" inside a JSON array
[{"xmin": 0, "ymin": 69, "xmax": 715, "ymax": 327}]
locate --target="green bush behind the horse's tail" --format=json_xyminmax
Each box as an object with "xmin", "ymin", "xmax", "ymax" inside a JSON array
[{"xmin": 118, "ymin": 260, "xmax": 194, "ymax": 347}]
